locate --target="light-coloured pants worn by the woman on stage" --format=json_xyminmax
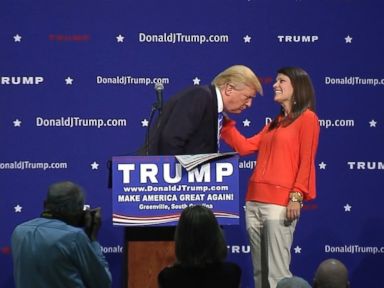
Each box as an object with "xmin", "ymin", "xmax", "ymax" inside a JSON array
[{"xmin": 245, "ymin": 201, "xmax": 297, "ymax": 288}]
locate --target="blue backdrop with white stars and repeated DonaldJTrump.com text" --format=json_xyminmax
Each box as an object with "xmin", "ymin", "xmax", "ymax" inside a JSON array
[{"xmin": 0, "ymin": 0, "xmax": 384, "ymax": 287}]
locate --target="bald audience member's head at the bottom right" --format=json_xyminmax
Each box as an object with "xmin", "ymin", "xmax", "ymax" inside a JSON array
[{"xmin": 313, "ymin": 259, "xmax": 349, "ymax": 288}]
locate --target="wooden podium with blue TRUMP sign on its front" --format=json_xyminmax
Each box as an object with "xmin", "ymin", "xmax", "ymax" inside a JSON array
[{"xmin": 112, "ymin": 155, "xmax": 239, "ymax": 288}]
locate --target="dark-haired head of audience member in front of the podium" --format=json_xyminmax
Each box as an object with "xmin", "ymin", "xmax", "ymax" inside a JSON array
[{"xmin": 175, "ymin": 205, "xmax": 227, "ymax": 266}]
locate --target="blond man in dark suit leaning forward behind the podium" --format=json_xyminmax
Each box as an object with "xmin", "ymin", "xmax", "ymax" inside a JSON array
[{"xmin": 148, "ymin": 65, "xmax": 262, "ymax": 155}]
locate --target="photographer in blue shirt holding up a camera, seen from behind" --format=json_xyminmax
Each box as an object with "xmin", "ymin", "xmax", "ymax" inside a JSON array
[{"xmin": 12, "ymin": 181, "xmax": 112, "ymax": 288}]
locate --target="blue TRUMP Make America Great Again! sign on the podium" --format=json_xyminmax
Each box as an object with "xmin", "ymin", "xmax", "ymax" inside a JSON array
[{"xmin": 112, "ymin": 155, "xmax": 239, "ymax": 226}]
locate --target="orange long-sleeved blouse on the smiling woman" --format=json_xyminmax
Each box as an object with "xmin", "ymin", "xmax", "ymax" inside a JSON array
[{"xmin": 221, "ymin": 109, "xmax": 320, "ymax": 206}]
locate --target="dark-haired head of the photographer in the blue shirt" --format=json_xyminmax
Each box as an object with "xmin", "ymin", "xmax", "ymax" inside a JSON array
[{"xmin": 43, "ymin": 181, "xmax": 84, "ymax": 226}]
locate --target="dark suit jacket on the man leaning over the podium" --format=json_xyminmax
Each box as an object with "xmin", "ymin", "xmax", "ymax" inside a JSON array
[{"xmin": 148, "ymin": 86, "xmax": 218, "ymax": 155}]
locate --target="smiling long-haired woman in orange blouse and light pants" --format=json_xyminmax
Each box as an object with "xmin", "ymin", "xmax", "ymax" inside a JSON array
[{"xmin": 221, "ymin": 67, "xmax": 320, "ymax": 288}]
